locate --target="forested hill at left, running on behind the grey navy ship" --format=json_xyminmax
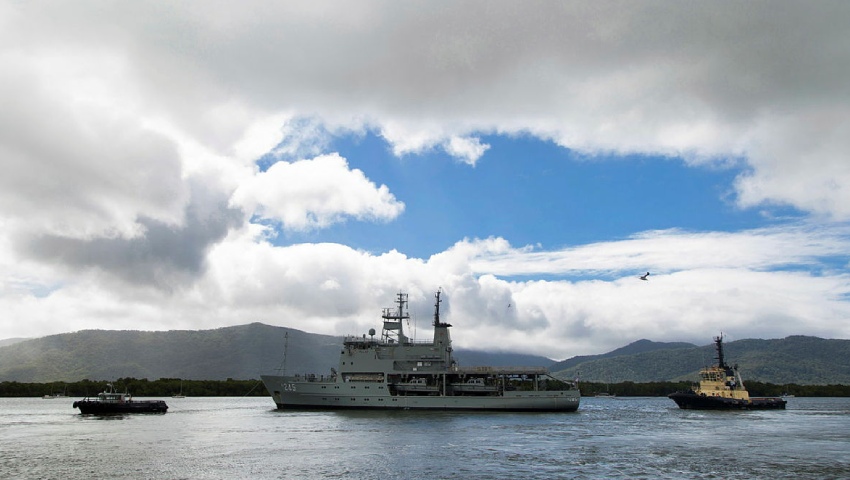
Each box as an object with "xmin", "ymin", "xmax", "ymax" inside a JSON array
[{"xmin": 0, "ymin": 323, "xmax": 553, "ymax": 382}]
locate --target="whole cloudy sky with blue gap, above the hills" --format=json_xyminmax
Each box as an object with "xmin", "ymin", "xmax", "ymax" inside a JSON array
[{"xmin": 0, "ymin": 0, "xmax": 850, "ymax": 360}]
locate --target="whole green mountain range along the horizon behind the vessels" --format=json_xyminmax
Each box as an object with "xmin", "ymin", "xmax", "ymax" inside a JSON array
[{"xmin": 0, "ymin": 323, "xmax": 850, "ymax": 385}]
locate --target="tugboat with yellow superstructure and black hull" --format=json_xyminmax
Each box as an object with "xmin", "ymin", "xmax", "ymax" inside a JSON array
[{"xmin": 667, "ymin": 334, "xmax": 787, "ymax": 410}]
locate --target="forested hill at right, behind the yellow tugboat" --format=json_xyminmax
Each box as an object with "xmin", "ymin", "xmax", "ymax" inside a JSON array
[{"xmin": 552, "ymin": 336, "xmax": 850, "ymax": 385}]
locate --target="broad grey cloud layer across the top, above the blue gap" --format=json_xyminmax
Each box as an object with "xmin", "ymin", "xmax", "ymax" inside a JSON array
[{"xmin": 3, "ymin": 2, "xmax": 850, "ymax": 214}]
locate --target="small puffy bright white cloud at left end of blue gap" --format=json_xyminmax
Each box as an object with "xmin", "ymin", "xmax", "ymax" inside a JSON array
[{"xmin": 233, "ymin": 154, "xmax": 404, "ymax": 230}]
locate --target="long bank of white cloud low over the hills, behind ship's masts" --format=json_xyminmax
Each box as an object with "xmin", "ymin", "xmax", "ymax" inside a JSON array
[{"xmin": 6, "ymin": 219, "xmax": 850, "ymax": 359}]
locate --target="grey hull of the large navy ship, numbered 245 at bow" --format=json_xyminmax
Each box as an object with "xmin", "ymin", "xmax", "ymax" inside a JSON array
[{"xmin": 262, "ymin": 375, "xmax": 581, "ymax": 412}]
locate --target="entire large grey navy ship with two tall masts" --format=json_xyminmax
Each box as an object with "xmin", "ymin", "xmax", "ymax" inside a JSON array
[{"xmin": 261, "ymin": 291, "xmax": 581, "ymax": 412}]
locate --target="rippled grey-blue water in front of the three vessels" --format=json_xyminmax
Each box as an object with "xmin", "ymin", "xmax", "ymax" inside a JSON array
[{"xmin": 0, "ymin": 398, "xmax": 850, "ymax": 479}]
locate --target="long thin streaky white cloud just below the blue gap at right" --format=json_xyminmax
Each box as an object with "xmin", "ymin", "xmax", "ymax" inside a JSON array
[{"xmin": 464, "ymin": 224, "xmax": 850, "ymax": 276}]
